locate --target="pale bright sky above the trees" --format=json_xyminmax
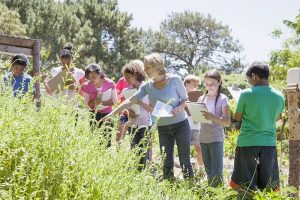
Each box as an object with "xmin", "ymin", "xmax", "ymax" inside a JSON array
[{"xmin": 118, "ymin": 0, "xmax": 300, "ymax": 64}]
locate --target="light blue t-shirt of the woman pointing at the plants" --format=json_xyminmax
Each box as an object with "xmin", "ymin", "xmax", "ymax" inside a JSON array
[{"xmin": 133, "ymin": 74, "xmax": 188, "ymax": 126}]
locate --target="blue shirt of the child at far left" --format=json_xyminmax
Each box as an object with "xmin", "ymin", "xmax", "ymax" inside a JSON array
[{"xmin": 4, "ymin": 72, "xmax": 34, "ymax": 97}]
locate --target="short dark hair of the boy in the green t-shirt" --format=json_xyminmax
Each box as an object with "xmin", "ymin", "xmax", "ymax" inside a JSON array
[{"xmin": 246, "ymin": 61, "xmax": 270, "ymax": 80}]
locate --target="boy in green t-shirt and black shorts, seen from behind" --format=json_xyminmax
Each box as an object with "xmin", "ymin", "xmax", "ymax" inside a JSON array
[{"xmin": 230, "ymin": 62, "xmax": 284, "ymax": 194}]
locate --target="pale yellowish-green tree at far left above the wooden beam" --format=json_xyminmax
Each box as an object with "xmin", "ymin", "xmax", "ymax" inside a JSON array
[{"xmin": 0, "ymin": 4, "xmax": 26, "ymax": 36}]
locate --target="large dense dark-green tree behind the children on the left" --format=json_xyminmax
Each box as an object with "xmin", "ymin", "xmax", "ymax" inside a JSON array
[{"xmin": 5, "ymin": 0, "xmax": 143, "ymax": 77}]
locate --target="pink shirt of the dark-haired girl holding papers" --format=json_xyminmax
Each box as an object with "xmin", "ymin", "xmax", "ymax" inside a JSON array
[{"xmin": 82, "ymin": 78, "xmax": 116, "ymax": 113}]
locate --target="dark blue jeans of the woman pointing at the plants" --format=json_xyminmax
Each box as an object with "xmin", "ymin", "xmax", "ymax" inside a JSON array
[{"xmin": 158, "ymin": 119, "xmax": 194, "ymax": 179}]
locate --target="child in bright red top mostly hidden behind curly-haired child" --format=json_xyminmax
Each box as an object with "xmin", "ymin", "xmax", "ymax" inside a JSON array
[{"xmin": 116, "ymin": 76, "xmax": 129, "ymax": 143}]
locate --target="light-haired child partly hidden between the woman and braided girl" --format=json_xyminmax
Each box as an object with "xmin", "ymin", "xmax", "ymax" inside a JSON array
[{"xmin": 183, "ymin": 75, "xmax": 203, "ymax": 170}]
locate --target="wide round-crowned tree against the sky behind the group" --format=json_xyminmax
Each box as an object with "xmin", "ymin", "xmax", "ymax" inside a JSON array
[{"xmin": 146, "ymin": 11, "xmax": 242, "ymax": 73}]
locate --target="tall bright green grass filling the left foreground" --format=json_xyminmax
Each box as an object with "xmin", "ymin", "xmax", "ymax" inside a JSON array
[{"xmin": 0, "ymin": 90, "xmax": 296, "ymax": 199}]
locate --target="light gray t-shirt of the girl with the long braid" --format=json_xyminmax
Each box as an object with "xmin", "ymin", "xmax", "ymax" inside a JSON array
[{"xmin": 199, "ymin": 94, "xmax": 229, "ymax": 143}]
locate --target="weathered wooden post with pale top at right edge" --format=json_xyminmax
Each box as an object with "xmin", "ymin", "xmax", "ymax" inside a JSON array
[{"xmin": 286, "ymin": 68, "xmax": 300, "ymax": 196}]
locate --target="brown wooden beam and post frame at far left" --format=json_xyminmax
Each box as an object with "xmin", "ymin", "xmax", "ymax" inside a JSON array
[{"xmin": 0, "ymin": 35, "xmax": 41, "ymax": 107}]
